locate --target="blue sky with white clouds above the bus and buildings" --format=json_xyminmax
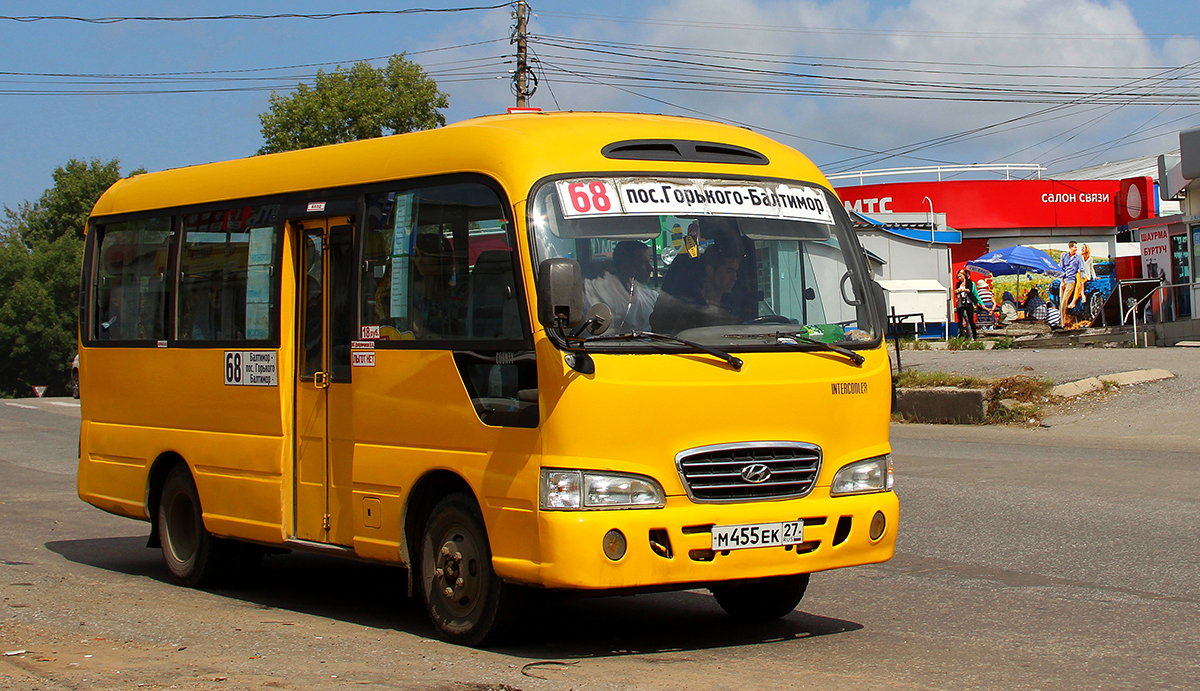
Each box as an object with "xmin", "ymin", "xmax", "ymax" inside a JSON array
[{"xmin": 0, "ymin": 0, "xmax": 1200, "ymax": 208}]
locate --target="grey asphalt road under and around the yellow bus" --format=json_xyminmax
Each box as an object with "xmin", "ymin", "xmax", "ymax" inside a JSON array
[{"xmin": 0, "ymin": 371, "xmax": 1200, "ymax": 691}]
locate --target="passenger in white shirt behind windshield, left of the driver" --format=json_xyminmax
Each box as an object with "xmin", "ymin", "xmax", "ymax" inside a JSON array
[{"xmin": 583, "ymin": 240, "xmax": 659, "ymax": 334}]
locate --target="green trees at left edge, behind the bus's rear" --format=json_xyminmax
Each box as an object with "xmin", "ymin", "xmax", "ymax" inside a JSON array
[{"xmin": 0, "ymin": 158, "xmax": 144, "ymax": 396}]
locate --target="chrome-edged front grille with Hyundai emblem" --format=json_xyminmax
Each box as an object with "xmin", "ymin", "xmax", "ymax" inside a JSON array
[{"xmin": 676, "ymin": 441, "xmax": 821, "ymax": 501}]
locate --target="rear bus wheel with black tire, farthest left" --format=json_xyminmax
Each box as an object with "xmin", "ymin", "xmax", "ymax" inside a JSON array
[{"xmin": 158, "ymin": 464, "xmax": 236, "ymax": 588}]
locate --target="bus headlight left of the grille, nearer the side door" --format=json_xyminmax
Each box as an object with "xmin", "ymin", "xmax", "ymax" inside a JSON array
[{"xmin": 540, "ymin": 468, "xmax": 666, "ymax": 510}]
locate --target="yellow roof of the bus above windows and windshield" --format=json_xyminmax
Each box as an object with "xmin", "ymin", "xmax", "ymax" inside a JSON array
[{"xmin": 92, "ymin": 112, "xmax": 829, "ymax": 216}]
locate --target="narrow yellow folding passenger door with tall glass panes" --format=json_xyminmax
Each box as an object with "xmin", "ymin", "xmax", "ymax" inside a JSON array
[{"xmin": 294, "ymin": 216, "xmax": 354, "ymax": 546}]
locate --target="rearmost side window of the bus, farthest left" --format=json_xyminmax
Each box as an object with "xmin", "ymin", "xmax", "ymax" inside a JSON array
[{"xmin": 89, "ymin": 216, "xmax": 174, "ymax": 341}]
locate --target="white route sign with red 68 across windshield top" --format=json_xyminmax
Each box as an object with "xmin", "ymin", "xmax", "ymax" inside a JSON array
[{"xmin": 557, "ymin": 178, "xmax": 833, "ymax": 226}]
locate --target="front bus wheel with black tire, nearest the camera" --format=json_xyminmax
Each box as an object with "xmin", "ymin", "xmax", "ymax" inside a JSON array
[{"xmin": 420, "ymin": 494, "xmax": 520, "ymax": 645}]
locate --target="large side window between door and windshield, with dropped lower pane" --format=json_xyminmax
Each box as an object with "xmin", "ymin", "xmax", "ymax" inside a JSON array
[{"xmin": 359, "ymin": 182, "xmax": 538, "ymax": 427}]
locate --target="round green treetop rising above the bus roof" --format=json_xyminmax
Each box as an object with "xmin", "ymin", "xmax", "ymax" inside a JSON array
[{"xmin": 258, "ymin": 54, "xmax": 450, "ymax": 154}]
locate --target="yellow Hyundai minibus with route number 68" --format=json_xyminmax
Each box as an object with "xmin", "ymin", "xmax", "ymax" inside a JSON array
[{"xmin": 78, "ymin": 113, "xmax": 898, "ymax": 644}]
